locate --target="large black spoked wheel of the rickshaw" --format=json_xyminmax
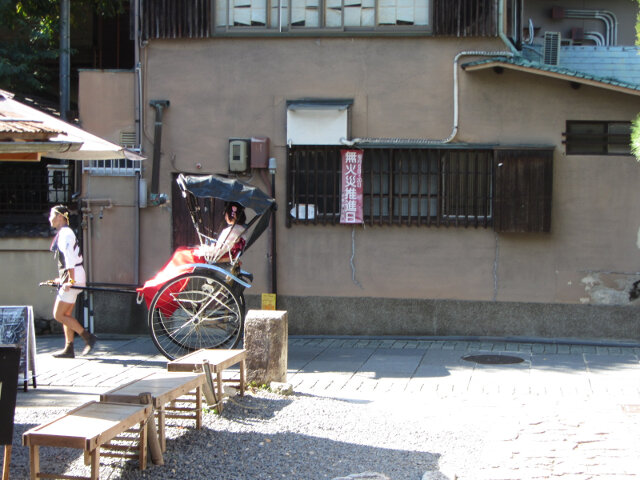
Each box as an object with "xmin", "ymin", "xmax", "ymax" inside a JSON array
[{"xmin": 148, "ymin": 272, "xmax": 244, "ymax": 360}]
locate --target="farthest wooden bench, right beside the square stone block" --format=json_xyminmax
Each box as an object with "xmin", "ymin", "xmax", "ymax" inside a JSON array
[{"xmin": 167, "ymin": 348, "xmax": 247, "ymax": 412}]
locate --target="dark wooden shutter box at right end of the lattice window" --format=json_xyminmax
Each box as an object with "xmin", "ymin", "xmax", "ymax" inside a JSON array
[{"xmin": 493, "ymin": 149, "xmax": 553, "ymax": 233}]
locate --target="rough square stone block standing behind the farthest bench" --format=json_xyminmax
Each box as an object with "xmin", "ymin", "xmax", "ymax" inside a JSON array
[{"xmin": 244, "ymin": 310, "xmax": 289, "ymax": 385}]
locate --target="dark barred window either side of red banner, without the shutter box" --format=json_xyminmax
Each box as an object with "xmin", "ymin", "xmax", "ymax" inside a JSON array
[{"xmin": 287, "ymin": 146, "xmax": 494, "ymax": 228}]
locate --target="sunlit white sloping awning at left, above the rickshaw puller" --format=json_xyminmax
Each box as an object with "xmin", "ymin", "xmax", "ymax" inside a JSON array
[{"xmin": 0, "ymin": 90, "xmax": 145, "ymax": 160}]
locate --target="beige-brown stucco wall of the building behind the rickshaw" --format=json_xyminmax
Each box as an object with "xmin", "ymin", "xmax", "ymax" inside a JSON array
[{"xmin": 130, "ymin": 38, "xmax": 640, "ymax": 303}]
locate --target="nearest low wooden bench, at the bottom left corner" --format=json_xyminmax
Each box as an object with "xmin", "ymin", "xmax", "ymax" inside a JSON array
[{"xmin": 22, "ymin": 402, "xmax": 153, "ymax": 480}]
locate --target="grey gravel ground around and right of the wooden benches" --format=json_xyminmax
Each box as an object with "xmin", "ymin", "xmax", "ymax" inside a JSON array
[{"xmin": 11, "ymin": 390, "xmax": 482, "ymax": 480}]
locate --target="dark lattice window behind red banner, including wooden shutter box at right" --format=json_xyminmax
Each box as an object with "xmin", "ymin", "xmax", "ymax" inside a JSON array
[{"xmin": 287, "ymin": 146, "xmax": 553, "ymax": 232}]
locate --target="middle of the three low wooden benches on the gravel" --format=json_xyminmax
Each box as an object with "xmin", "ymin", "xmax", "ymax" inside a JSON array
[{"xmin": 100, "ymin": 372, "xmax": 206, "ymax": 452}]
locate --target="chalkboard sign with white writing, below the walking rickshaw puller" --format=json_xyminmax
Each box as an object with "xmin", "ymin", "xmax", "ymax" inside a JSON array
[{"xmin": 0, "ymin": 305, "xmax": 36, "ymax": 392}]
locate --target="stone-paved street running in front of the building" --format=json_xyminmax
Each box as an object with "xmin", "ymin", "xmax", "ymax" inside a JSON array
[{"xmin": 18, "ymin": 337, "xmax": 640, "ymax": 480}]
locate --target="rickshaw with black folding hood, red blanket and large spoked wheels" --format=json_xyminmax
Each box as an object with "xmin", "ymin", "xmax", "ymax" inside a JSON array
[{"xmin": 137, "ymin": 174, "xmax": 276, "ymax": 360}]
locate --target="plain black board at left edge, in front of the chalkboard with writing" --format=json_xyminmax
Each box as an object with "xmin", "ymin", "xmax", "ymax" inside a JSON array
[{"xmin": 0, "ymin": 345, "xmax": 21, "ymax": 444}]
